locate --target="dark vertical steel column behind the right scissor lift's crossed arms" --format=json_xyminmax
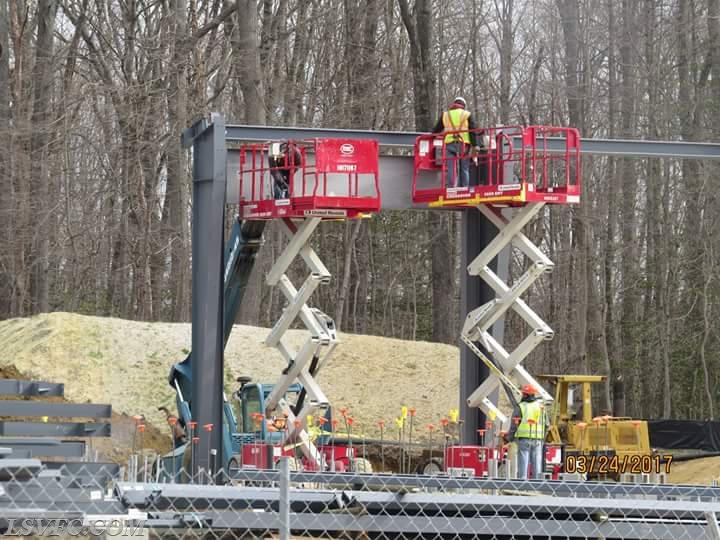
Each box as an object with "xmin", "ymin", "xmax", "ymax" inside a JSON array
[{"xmin": 459, "ymin": 208, "xmax": 509, "ymax": 444}]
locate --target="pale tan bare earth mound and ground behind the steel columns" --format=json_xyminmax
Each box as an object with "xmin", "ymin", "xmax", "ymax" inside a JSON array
[{"xmin": 0, "ymin": 313, "xmax": 720, "ymax": 484}]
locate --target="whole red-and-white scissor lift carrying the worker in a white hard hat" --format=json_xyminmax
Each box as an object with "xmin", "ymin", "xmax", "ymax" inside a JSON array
[{"xmin": 412, "ymin": 126, "xmax": 580, "ymax": 474}]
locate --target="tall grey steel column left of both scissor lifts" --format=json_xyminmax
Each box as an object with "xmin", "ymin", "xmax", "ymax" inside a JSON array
[{"xmin": 183, "ymin": 114, "xmax": 227, "ymax": 474}]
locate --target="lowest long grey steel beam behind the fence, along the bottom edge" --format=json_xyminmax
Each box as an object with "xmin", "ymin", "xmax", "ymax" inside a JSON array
[{"xmin": 144, "ymin": 512, "xmax": 705, "ymax": 540}]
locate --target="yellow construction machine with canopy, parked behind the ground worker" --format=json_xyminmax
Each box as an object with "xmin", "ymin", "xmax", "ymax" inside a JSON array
[{"xmin": 538, "ymin": 375, "xmax": 657, "ymax": 477}]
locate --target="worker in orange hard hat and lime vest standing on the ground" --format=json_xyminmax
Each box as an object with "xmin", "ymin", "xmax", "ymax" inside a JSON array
[{"xmin": 507, "ymin": 384, "xmax": 550, "ymax": 480}]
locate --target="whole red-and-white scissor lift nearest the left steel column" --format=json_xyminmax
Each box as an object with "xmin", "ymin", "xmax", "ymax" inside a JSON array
[{"xmin": 239, "ymin": 139, "xmax": 380, "ymax": 472}]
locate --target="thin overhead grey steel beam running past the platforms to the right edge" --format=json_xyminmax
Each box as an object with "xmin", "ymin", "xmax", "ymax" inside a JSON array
[{"xmin": 225, "ymin": 125, "xmax": 720, "ymax": 159}]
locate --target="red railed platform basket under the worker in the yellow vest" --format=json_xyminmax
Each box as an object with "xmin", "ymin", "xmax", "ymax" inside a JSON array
[{"xmin": 412, "ymin": 126, "xmax": 580, "ymax": 207}]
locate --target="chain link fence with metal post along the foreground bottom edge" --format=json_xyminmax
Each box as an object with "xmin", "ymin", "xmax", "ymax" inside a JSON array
[{"xmin": 0, "ymin": 458, "xmax": 720, "ymax": 540}]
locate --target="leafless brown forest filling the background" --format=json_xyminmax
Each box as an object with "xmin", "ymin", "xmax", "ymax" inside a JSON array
[{"xmin": 0, "ymin": 0, "xmax": 720, "ymax": 418}]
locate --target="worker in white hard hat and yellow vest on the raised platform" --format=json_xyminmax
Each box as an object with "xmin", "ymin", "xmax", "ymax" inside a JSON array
[{"xmin": 433, "ymin": 97, "xmax": 480, "ymax": 187}]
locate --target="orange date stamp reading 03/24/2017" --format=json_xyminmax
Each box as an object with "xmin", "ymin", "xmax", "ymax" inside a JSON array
[{"xmin": 563, "ymin": 454, "xmax": 673, "ymax": 474}]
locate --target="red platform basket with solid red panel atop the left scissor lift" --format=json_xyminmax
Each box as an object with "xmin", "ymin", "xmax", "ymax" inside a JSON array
[{"xmin": 239, "ymin": 139, "xmax": 380, "ymax": 220}]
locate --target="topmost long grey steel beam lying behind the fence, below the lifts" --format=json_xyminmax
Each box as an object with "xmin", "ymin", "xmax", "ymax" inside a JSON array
[{"xmin": 230, "ymin": 469, "xmax": 720, "ymax": 501}]
